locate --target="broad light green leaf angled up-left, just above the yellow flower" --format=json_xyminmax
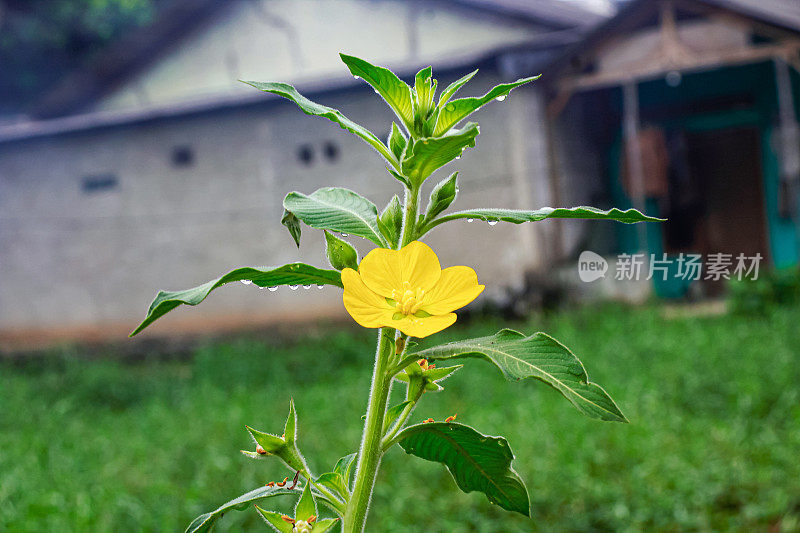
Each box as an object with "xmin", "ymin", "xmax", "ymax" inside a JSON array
[{"xmin": 283, "ymin": 187, "xmax": 386, "ymax": 247}]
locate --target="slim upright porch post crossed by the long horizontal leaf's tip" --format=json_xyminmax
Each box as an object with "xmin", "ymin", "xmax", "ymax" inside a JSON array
[{"xmin": 622, "ymin": 81, "xmax": 650, "ymax": 252}]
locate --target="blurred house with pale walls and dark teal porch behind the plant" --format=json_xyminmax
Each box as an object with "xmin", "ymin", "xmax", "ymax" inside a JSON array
[{"xmin": 0, "ymin": 0, "xmax": 800, "ymax": 344}]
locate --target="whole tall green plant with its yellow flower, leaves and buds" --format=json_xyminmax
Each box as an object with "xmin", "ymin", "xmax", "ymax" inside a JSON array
[{"xmin": 132, "ymin": 54, "xmax": 658, "ymax": 533}]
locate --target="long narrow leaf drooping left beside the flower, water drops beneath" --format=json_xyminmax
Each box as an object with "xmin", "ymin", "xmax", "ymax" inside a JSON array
[{"xmin": 130, "ymin": 263, "xmax": 342, "ymax": 337}]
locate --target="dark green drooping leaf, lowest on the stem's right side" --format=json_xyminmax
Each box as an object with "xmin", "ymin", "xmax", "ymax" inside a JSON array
[{"xmin": 397, "ymin": 422, "xmax": 530, "ymax": 516}]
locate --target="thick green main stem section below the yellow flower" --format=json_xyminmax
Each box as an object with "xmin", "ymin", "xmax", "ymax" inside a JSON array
[{"xmin": 342, "ymin": 328, "xmax": 395, "ymax": 533}]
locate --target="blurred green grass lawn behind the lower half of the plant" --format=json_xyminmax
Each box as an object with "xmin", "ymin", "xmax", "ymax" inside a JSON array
[{"xmin": 0, "ymin": 306, "xmax": 800, "ymax": 533}]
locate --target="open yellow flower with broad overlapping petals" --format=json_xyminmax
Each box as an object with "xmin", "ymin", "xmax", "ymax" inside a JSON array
[{"xmin": 342, "ymin": 241, "xmax": 483, "ymax": 338}]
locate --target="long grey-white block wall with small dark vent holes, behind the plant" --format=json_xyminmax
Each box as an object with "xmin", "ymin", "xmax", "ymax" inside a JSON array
[{"xmin": 0, "ymin": 73, "xmax": 547, "ymax": 336}]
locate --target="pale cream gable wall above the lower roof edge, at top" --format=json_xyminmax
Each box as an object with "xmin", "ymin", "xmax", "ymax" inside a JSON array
[{"xmin": 96, "ymin": 0, "xmax": 541, "ymax": 110}]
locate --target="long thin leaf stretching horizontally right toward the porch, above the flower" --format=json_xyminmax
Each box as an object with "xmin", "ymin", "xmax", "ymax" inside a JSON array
[{"xmin": 427, "ymin": 206, "xmax": 664, "ymax": 229}]
